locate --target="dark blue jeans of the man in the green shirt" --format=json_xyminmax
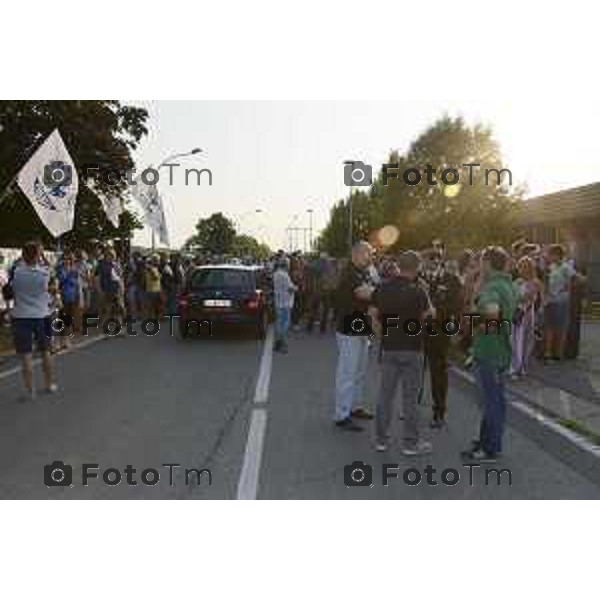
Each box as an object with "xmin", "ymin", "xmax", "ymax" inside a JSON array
[{"xmin": 475, "ymin": 360, "xmax": 506, "ymax": 454}]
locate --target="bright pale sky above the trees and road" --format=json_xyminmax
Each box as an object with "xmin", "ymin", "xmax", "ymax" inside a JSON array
[{"xmin": 127, "ymin": 99, "xmax": 600, "ymax": 249}]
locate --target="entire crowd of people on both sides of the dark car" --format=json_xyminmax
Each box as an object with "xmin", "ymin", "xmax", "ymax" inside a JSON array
[{"xmin": 0, "ymin": 234, "xmax": 585, "ymax": 462}]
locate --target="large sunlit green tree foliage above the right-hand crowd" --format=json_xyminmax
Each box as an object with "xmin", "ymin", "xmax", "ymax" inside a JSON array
[{"xmin": 319, "ymin": 117, "xmax": 522, "ymax": 256}]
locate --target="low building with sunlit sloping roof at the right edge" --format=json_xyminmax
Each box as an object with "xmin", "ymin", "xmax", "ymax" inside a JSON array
[{"xmin": 519, "ymin": 183, "xmax": 600, "ymax": 302}]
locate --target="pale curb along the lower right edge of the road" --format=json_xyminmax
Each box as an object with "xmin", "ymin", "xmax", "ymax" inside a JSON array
[{"xmin": 450, "ymin": 366, "xmax": 600, "ymax": 486}]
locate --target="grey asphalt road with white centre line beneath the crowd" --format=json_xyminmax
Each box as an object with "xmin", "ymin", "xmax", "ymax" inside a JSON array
[{"xmin": 0, "ymin": 329, "xmax": 600, "ymax": 499}]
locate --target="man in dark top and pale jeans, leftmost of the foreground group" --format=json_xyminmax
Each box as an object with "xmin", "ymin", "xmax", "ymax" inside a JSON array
[{"xmin": 334, "ymin": 241, "xmax": 375, "ymax": 431}]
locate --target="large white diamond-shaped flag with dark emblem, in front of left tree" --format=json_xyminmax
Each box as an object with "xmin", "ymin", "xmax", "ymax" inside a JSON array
[{"xmin": 17, "ymin": 129, "xmax": 79, "ymax": 237}]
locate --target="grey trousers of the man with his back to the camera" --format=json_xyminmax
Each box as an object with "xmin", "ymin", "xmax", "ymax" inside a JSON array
[{"xmin": 375, "ymin": 350, "xmax": 423, "ymax": 447}]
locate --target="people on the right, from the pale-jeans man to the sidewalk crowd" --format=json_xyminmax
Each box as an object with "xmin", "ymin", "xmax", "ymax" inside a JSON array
[{"xmin": 292, "ymin": 240, "xmax": 585, "ymax": 462}]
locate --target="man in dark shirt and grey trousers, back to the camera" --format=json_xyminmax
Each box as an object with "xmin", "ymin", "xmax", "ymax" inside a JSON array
[{"xmin": 369, "ymin": 251, "xmax": 433, "ymax": 456}]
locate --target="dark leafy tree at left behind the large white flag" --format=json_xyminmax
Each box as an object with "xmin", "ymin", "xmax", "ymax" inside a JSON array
[{"xmin": 0, "ymin": 100, "xmax": 148, "ymax": 246}]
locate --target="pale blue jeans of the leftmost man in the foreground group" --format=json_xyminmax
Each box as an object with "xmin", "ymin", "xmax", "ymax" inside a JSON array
[{"xmin": 334, "ymin": 333, "xmax": 369, "ymax": 421}]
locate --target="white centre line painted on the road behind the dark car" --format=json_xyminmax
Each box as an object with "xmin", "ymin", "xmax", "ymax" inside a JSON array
[{"xmin": 237, "ymin": 327, "xmax": 273, "ymax": 500}]
